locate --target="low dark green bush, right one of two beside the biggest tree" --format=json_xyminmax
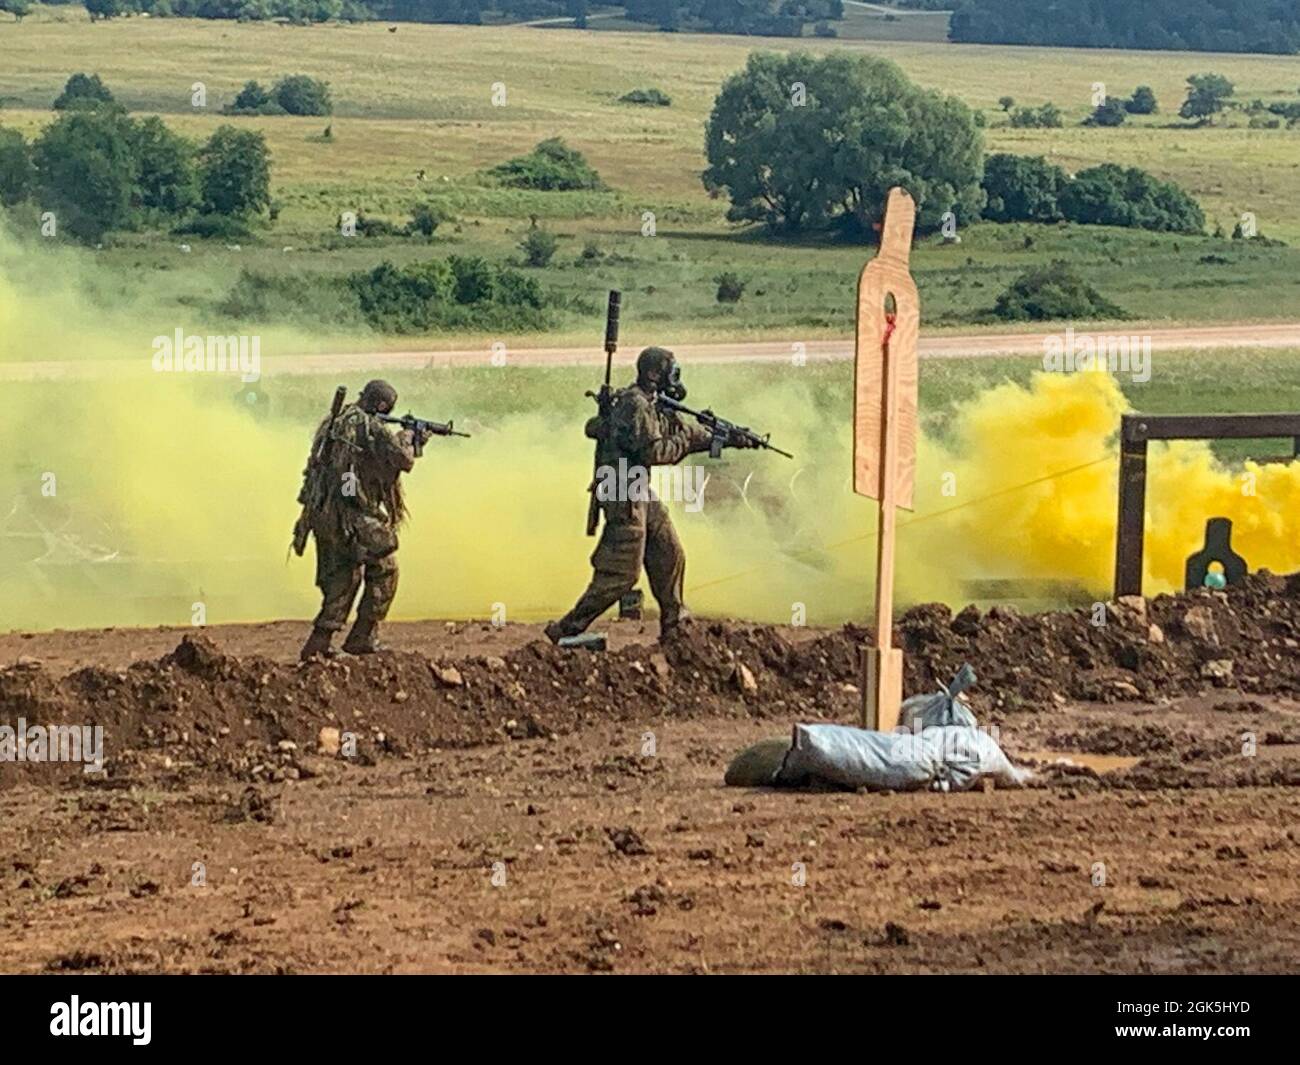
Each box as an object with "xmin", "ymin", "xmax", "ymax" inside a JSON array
[{"xmin": 1060, "ymin": 163, "xmax": 1205, "ymax": 233}]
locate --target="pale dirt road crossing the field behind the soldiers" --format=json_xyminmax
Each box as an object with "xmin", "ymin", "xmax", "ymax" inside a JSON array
[{"xmin": 0, "ymin": 322, "xmax": 1300, "ymax": 381}]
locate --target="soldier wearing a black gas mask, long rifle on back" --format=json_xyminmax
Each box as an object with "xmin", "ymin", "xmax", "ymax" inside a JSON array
[{"xmin": 546, "ymin": 347, "xmax": 757, "ymax": 642}]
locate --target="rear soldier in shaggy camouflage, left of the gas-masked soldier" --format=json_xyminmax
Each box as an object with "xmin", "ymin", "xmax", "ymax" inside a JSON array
[{"xmin": 294, "ymin": 381, "xmax": 424, "ymax": 661}]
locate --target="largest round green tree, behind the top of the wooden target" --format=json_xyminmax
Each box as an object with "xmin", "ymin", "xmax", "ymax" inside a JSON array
[{"xmin": 703, "ymin": 52, "xmax": 983, "ymax": 234}]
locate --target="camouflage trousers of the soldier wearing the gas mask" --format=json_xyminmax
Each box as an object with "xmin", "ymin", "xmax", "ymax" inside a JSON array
[{"xmin": 559, "ymin": 499, "xmax": 686, "ymax": 636}]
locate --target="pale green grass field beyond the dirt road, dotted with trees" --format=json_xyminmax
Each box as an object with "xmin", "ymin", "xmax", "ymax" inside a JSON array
[{"xmin": 0, "ymin": 9, "xmax": 1300, "ymax": 338}]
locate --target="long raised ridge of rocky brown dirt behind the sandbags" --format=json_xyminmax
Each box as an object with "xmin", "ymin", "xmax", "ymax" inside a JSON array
[{"xmin": 0, "ymin": 573, "xmax": 1300, "ymax": 784}]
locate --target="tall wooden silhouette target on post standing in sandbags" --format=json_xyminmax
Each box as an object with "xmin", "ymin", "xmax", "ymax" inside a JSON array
[{"xmin": 853, "ymin": 189, "xmax": 920, "ymax": 732}]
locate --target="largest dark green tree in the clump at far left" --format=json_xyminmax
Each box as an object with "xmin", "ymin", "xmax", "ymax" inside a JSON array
[{"xmin": 33, "ymin": 108, "xmax": 138, "ymax": 242}]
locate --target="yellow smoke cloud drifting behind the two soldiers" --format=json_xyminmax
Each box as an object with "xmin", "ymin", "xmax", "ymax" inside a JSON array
[{"xmin": 0, "ymin": 232, "xmax": 1300, "ymax": 628}]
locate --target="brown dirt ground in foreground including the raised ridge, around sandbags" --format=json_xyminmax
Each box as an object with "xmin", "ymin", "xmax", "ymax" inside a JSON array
[{"xmin": 0, "ymin": 576, "xmax": 1300, "ymax": 973}]
